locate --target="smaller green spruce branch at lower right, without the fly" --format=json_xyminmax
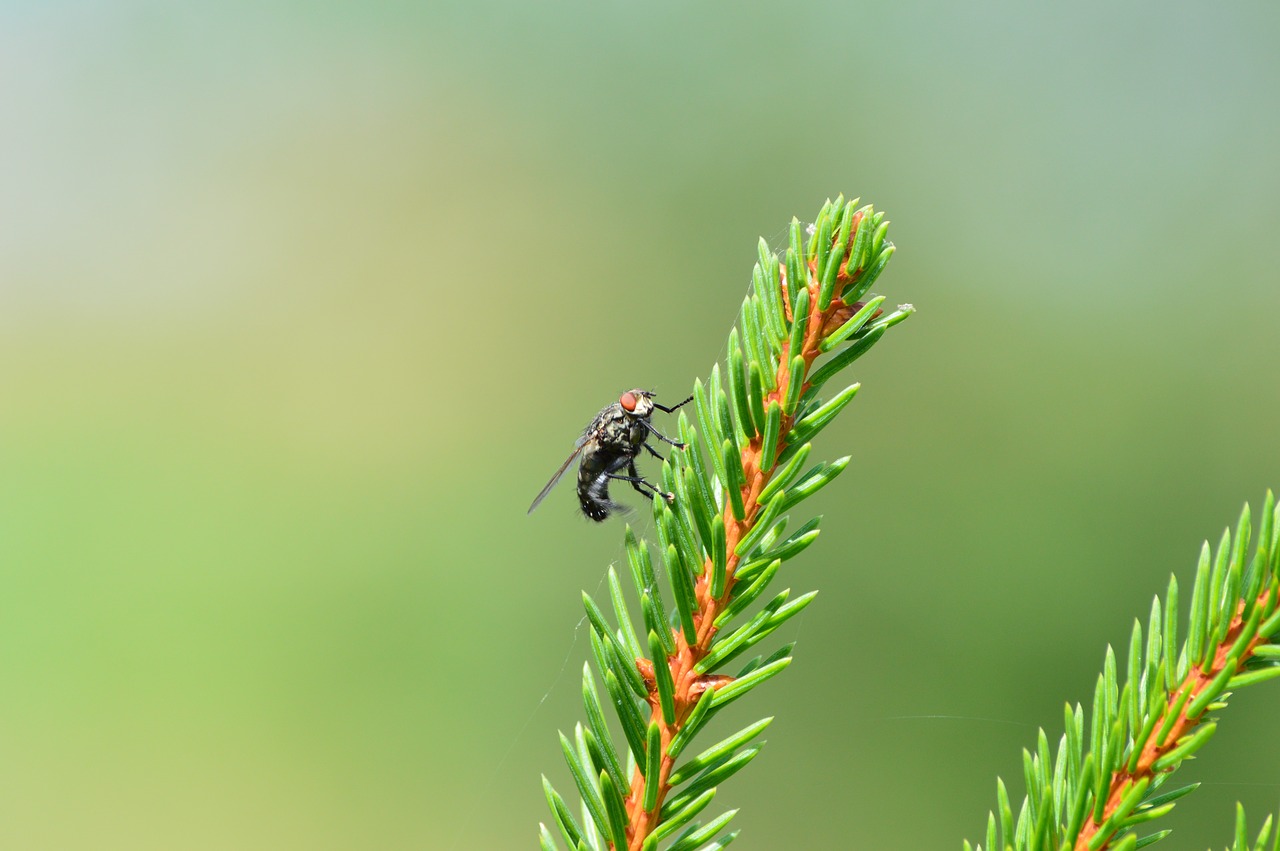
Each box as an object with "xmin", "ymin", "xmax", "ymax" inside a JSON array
[{"xmin": 964, "ymin": 491, "xmax": 1280, "ymax": 851}]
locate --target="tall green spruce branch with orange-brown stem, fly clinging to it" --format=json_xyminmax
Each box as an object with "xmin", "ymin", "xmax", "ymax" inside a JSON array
[{"xmin": 539, "ymin": 197, "xmax": 914, "ymax": 851}]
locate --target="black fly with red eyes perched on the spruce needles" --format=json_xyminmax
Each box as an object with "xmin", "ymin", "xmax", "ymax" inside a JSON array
[{"xmin": 529, "ymin": 389, "xmax": 694, "ymax": 522}]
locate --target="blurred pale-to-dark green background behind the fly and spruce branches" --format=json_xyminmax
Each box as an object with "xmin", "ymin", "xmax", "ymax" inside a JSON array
[{"xmin": 0, "ymin": 1, "xmax": 1280, "ymax": 851}]
